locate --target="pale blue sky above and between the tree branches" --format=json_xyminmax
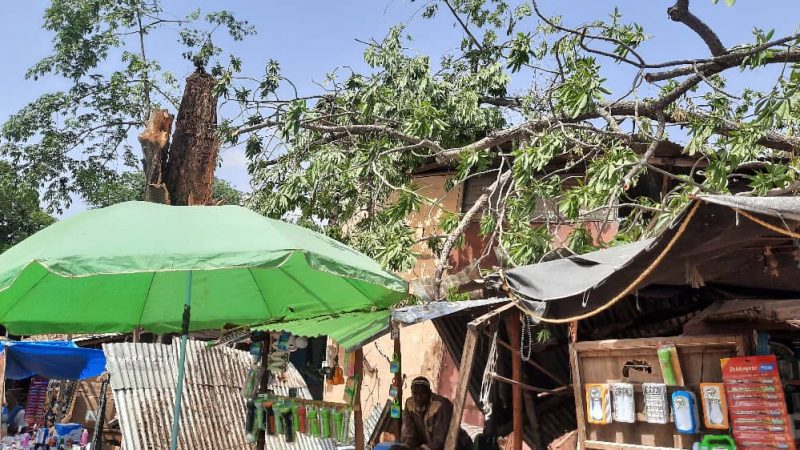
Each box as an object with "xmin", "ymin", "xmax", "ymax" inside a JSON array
[{"xmin": 0, "ymin": 0, "xmax": 800, "ymax": 211}]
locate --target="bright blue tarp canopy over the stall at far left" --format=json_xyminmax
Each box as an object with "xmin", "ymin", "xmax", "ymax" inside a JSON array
[{"xmin": 0, "ymin": 341, "xmax": 106, "ymax": 380}]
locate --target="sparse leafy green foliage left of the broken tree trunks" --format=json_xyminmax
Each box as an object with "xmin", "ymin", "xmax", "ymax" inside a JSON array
[{"xmin": 0, "ymin": 0, "xmax": 254, "ymax": 210}]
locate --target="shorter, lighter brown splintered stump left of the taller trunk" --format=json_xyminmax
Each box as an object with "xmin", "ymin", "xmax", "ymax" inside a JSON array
[{"xmin": 139, "ymin": 109, "xmax": 174, "ymax": 204}]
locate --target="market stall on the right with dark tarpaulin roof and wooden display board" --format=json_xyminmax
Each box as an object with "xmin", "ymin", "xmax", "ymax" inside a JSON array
[{"xmin": 482, "ymin": 196, "xmax": 800, "ymax": 450}]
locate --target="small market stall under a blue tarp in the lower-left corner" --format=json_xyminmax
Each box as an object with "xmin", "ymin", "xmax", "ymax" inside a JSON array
[{"xmin": 0, "ymin": 341, "xmax": 106, "ymax": 449}]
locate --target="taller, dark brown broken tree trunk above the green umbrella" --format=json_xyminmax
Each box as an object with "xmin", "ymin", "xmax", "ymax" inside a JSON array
[{"xmin": 164, "ymin": 70, "xmax": 219, "ymax": 205}]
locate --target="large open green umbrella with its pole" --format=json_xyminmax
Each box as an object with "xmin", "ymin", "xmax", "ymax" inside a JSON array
[{"xmin": 0, "ymin": 202, "xmax": 407, "ymax": 449}]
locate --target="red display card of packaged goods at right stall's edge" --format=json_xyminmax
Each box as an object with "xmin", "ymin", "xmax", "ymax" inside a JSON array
[{"xmin": 722, "ymin": 355, "xmax": 796, "ymax": 450}]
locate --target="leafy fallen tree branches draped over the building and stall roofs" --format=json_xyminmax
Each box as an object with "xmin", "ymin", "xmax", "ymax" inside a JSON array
[{"xmin": 223, "ymin": 0, "xmax": 800, "ymax": 296}]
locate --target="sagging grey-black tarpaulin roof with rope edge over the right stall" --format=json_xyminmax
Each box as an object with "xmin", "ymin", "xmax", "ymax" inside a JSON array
[{"xmin": 504, "ymin": 196, "xmax": 800, "ymax": 322}]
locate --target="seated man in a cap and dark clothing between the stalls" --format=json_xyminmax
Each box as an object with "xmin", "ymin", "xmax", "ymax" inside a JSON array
[{"xmin": 396, "ymin": 377, "xmax": 472, "ymax": 450}]
